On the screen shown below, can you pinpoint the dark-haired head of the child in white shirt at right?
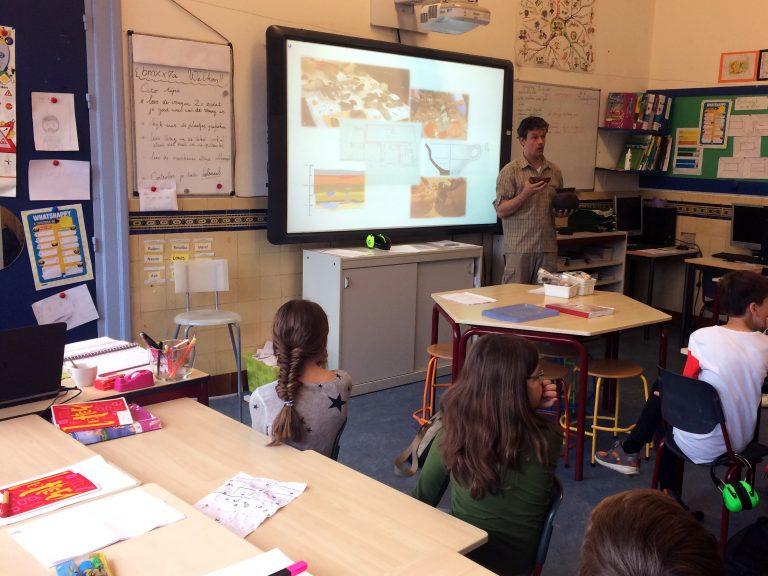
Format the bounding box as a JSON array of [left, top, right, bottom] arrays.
[[717, 271, 768, 330]]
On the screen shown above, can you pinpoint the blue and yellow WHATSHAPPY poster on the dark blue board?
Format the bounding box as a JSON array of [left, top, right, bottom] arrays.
[[21, 204, 93, 290]]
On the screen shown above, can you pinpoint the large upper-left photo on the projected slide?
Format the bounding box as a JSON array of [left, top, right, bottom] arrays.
[[301, 57, 411, 128]]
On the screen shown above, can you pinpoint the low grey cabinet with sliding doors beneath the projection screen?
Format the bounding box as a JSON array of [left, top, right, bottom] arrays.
[[303, 243, 482, 394]]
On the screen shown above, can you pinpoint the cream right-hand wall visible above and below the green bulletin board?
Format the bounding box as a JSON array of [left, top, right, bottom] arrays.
[[638, 0, 768, 311]]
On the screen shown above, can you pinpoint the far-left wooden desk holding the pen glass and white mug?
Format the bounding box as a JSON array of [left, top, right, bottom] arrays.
[[0, 366, 209, 421]]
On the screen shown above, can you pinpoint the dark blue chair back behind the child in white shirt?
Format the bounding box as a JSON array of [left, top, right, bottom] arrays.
[[659, 369, 725, 434]]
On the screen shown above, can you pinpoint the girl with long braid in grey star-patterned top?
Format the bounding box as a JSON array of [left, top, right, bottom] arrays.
[[250, 300, 352, 456]]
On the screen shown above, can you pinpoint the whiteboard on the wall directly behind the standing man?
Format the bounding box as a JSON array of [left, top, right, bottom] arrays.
[[512, 81, 600, 190]]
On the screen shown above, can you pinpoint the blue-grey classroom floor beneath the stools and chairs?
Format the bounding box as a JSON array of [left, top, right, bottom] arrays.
[[211, 330, 768, 576]]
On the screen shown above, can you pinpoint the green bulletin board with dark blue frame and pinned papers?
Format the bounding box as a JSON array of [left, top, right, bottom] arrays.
[[640, 86, 768, 195]]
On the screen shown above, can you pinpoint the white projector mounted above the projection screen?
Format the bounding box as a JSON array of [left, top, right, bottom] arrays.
[[371, 0, 491, 34]]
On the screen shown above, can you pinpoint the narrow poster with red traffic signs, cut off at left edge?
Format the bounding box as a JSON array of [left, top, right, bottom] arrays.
[[0, 25, 16, 196]]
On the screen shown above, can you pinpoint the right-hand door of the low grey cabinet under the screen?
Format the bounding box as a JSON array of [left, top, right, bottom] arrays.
[[414, 258, 475, 370]]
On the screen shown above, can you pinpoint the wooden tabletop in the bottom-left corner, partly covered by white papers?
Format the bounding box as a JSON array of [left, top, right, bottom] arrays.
[[0, 484, 260, 576]]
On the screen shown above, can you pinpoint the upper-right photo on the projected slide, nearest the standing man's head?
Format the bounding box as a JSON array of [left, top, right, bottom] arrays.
[[411, 89, 469, 140]]
